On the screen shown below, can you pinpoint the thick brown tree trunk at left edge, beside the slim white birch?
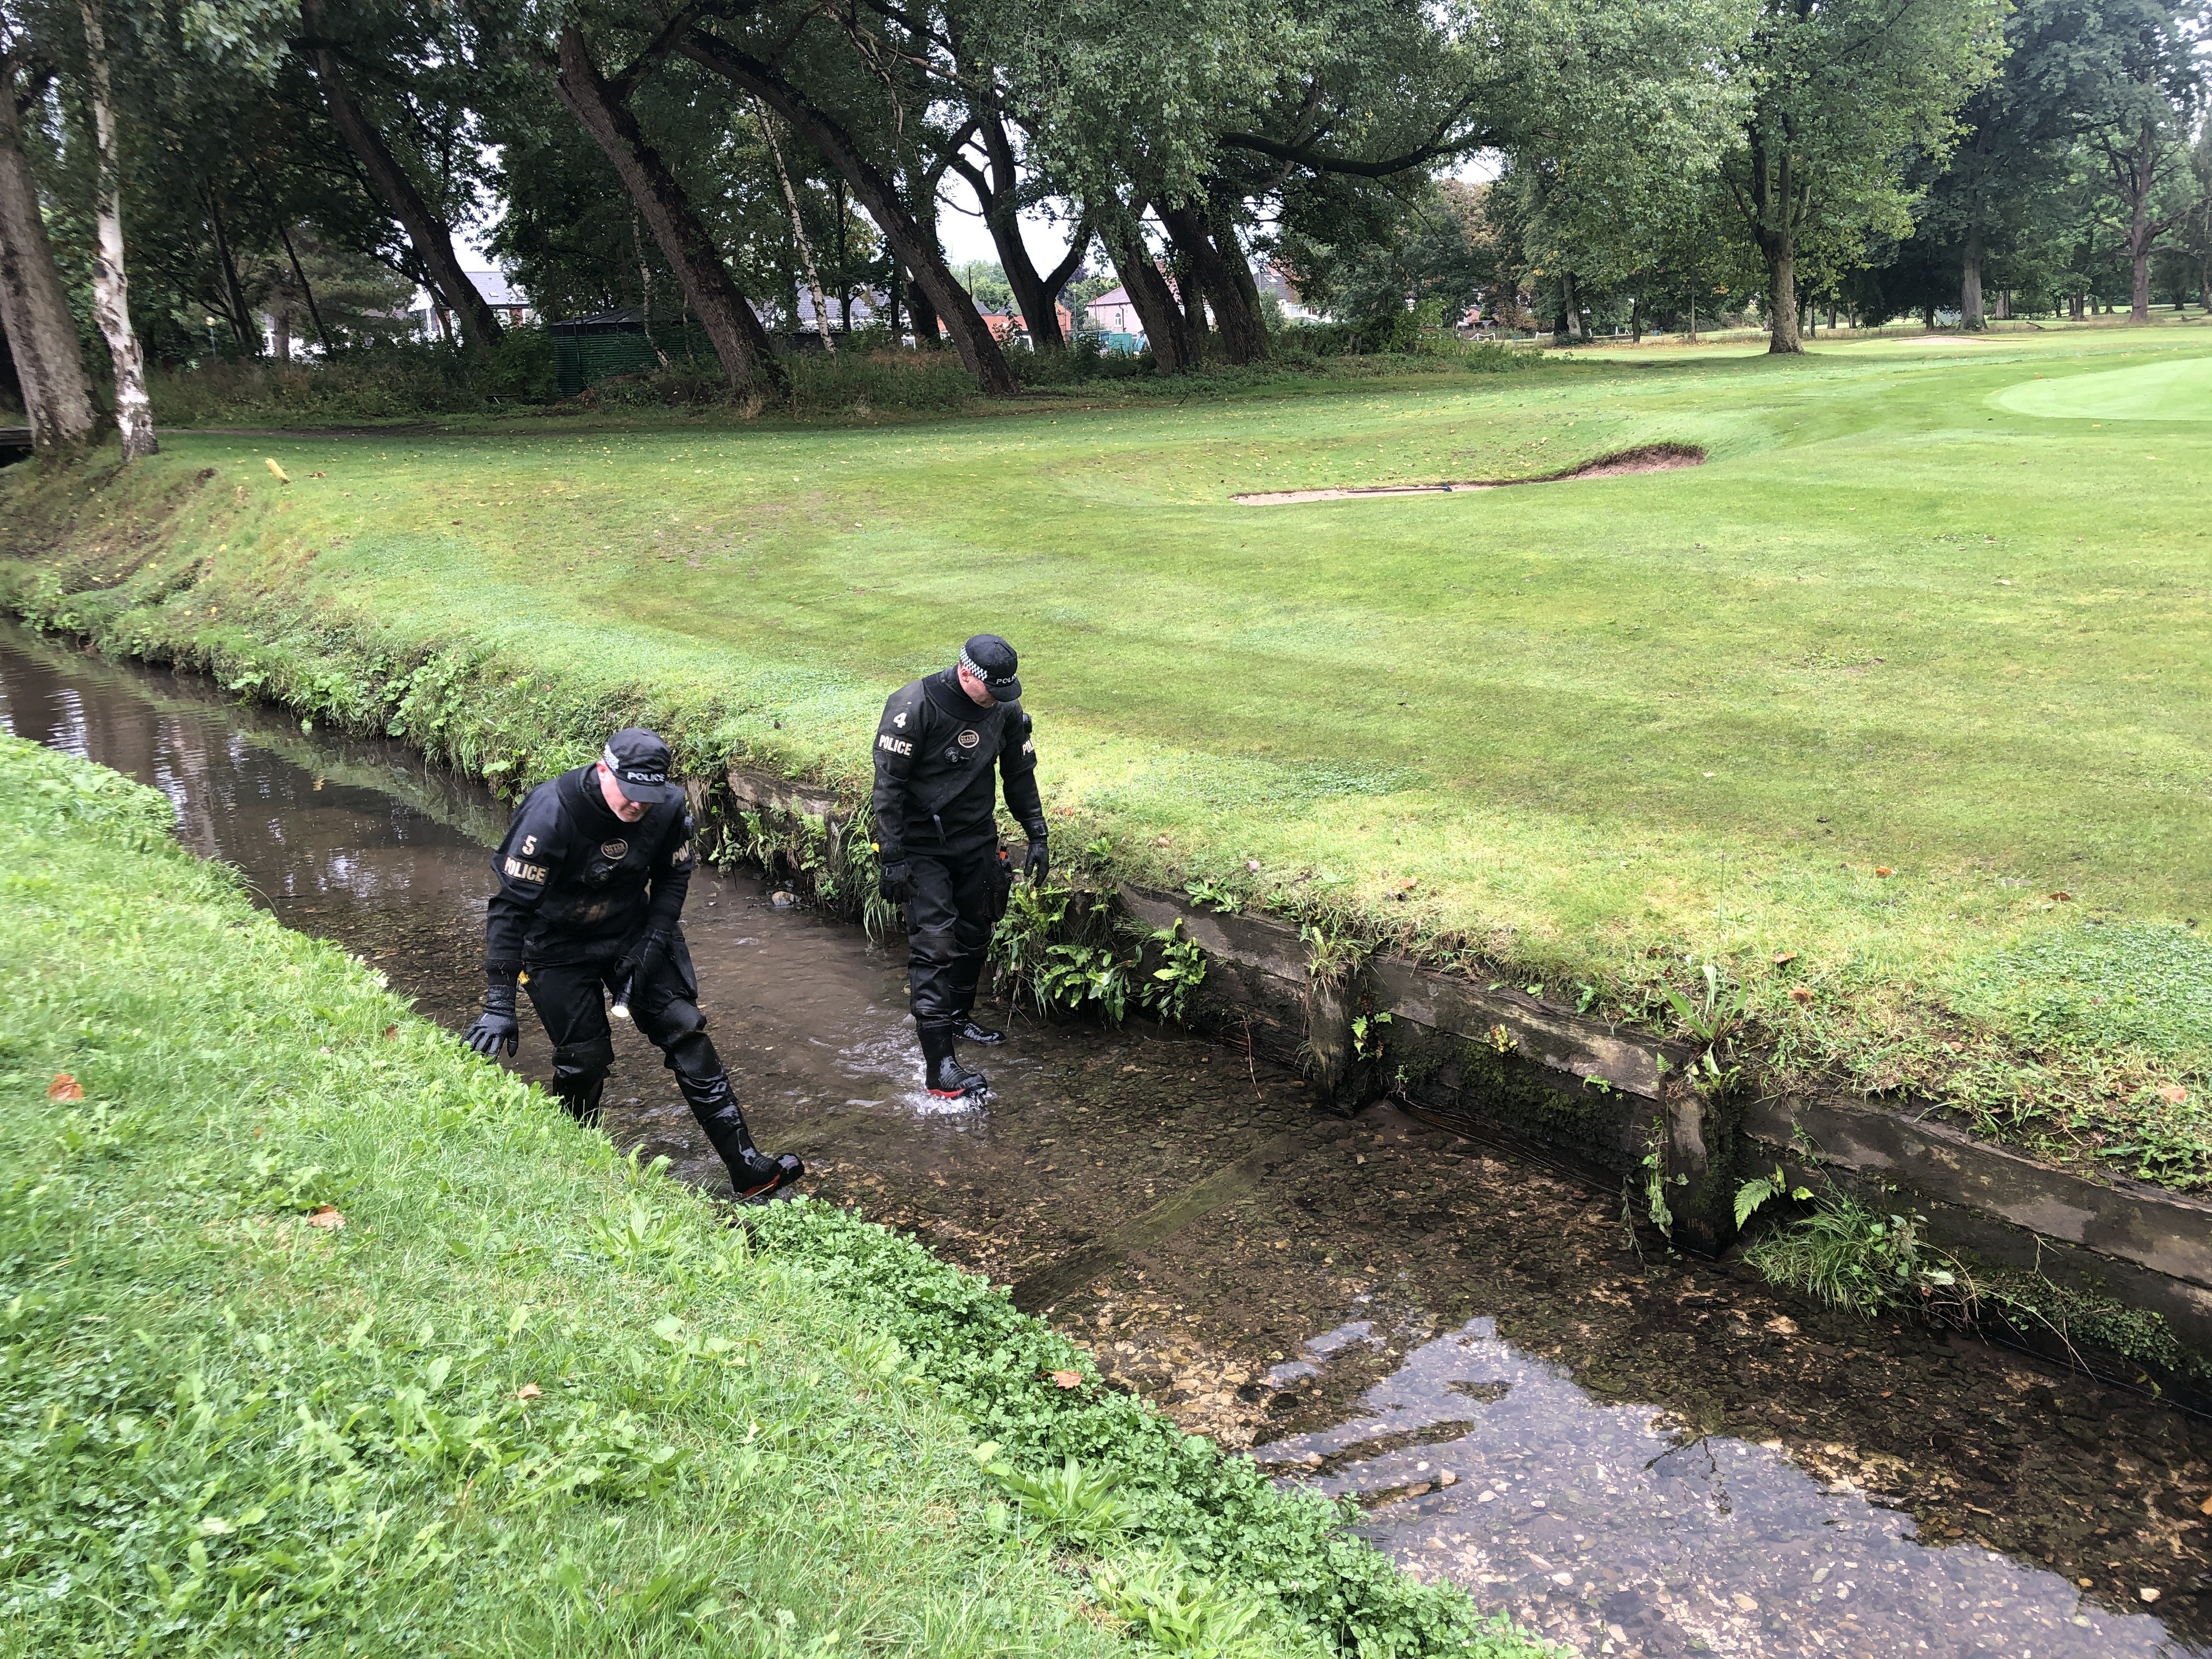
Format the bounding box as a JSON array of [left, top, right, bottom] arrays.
[[0, 55, 95, 456]]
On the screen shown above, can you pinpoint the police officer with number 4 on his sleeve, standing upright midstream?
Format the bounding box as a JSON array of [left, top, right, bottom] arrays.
[[876, 633, 1051, 1099]]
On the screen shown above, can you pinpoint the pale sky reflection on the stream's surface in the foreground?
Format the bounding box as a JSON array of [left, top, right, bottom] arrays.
[[1252, 1318, 2199, 1659]]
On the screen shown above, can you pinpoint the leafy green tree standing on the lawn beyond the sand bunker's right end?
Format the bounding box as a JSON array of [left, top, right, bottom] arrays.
[[1721, 0, 2004, 352]]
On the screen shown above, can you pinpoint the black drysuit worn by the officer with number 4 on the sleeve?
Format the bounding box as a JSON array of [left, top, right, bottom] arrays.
[[876, 668, 1044, 1031]]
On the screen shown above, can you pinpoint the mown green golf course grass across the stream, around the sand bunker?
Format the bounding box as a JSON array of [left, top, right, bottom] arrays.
[[0, 325, 2212, 1190]]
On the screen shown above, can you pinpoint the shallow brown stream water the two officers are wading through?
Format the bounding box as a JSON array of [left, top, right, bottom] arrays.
[[13, 630, 2212, 1659]]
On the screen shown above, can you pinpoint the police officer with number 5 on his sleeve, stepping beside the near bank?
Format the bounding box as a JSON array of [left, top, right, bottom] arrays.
[[469, 725, 805, 1199]]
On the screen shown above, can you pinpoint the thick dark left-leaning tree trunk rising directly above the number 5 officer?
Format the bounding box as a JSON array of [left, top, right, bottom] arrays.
[[553, 24, 785, 400]]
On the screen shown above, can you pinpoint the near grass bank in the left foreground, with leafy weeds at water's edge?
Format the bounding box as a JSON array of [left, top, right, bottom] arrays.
[[0, 739, 1535, 1659]]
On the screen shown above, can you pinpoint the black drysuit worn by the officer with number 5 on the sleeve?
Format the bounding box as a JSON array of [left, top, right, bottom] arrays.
[[484, 765, 735, 1124]]
